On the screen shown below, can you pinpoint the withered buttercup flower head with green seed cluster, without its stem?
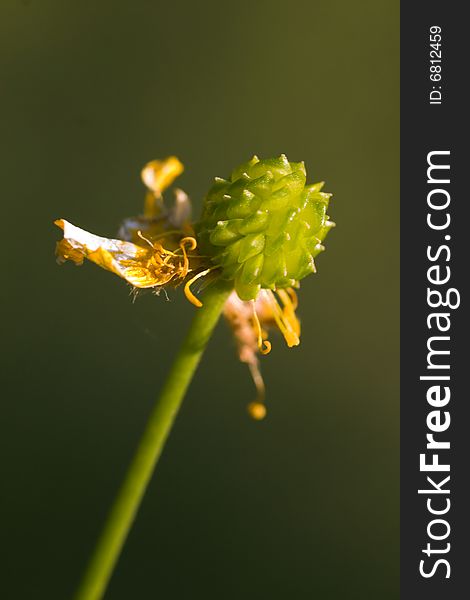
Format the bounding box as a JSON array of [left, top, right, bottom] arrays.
[[55, 155, 334, 419]]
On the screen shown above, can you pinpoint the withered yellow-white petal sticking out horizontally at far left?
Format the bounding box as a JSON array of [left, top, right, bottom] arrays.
[[55, 219, 193, 288]]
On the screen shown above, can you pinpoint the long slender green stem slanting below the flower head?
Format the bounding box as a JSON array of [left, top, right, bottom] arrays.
[[75, 283, 230, 600]]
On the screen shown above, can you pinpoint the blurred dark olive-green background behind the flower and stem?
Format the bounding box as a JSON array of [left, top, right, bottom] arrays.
[[0, 0, 399, 600]]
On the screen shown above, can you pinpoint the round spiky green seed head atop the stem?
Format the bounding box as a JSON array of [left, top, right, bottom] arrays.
[[198, 154, 333, 300]]
